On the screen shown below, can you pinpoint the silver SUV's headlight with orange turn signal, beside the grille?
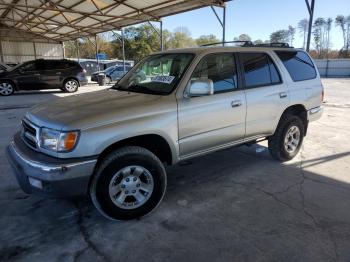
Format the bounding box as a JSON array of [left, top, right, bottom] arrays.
[[40, 128, 79, 152]]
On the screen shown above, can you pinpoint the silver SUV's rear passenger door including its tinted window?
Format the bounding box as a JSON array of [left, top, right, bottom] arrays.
[[239, 52, 289, 138]]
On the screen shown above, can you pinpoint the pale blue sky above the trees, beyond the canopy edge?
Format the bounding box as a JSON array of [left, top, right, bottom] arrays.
[[163, 0, 350, 49]]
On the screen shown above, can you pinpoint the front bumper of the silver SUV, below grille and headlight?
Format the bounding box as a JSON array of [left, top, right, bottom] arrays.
[[6, 137, 97, 197]]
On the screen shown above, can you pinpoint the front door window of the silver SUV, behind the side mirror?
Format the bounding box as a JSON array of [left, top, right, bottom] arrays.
[[191, 53, 238, 94]]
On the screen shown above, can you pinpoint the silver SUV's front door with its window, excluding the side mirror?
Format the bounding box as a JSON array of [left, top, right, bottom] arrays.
[[178, 53, 246, 158]]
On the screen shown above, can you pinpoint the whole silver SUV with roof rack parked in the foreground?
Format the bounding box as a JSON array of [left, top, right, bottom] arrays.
[[7, 46, 323, 220]]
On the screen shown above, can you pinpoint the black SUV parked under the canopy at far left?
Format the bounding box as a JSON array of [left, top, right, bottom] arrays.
[[0, 59, 88, 96]]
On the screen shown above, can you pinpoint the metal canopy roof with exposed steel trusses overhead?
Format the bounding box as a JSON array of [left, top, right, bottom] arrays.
[[0, 0, 227, 41]]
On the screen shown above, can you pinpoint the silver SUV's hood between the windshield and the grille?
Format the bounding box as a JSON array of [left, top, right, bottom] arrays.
[[26, 89, 164, 130]]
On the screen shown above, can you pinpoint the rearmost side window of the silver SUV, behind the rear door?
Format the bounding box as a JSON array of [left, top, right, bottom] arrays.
[[275, 51, 317, 82]]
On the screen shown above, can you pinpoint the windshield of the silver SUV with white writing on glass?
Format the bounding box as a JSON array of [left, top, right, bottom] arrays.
[[113, 53, 194, 95]]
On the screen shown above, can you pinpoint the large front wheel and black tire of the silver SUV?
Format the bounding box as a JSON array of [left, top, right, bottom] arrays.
[[90, 146, 167, 220]]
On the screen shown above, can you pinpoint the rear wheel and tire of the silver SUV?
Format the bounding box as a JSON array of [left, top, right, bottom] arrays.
[[268, 114, 305, 162]]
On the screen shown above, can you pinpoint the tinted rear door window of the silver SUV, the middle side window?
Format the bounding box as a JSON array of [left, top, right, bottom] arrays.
[[239, 53, 281, 87]]
